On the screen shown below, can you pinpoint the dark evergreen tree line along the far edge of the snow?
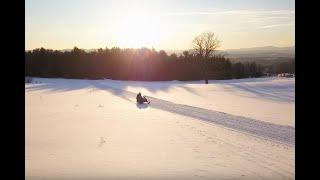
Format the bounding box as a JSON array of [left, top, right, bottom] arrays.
[[25, 47, 262, 81]]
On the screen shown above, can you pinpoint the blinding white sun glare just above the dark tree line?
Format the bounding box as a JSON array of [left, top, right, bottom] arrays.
[[116, 12, 160, 48]]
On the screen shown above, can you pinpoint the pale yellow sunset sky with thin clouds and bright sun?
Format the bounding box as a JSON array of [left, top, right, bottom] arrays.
[[25, 0, 295, 50]]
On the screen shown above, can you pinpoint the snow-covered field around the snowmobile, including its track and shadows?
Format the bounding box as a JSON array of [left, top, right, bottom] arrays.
[[25, 78, 295, 179]]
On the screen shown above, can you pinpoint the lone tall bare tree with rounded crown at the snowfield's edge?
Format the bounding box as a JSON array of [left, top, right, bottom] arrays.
[[193, 32, 220, 84]]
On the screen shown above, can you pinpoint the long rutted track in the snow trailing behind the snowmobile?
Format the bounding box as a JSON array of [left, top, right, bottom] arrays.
[[147, 96, 295, 145]]
